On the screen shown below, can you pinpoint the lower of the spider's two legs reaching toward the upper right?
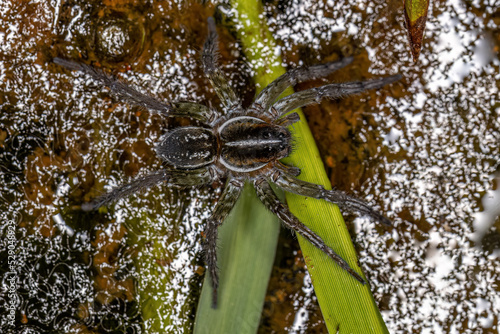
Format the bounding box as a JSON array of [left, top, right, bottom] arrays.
[[273, 74, 401, 117]]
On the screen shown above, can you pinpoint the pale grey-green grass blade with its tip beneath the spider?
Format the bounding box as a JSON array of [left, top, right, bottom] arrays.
[[194, 184, 279, 334]]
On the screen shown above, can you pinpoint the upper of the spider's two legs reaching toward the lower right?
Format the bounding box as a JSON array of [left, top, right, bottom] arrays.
[[273, 172, 391, 226]]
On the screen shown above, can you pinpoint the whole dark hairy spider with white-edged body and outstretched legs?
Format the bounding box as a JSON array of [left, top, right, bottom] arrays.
[[54, 19, 400, 307]]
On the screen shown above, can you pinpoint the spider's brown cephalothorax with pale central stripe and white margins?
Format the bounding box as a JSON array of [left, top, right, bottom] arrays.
[[219, 116, 291, 172]]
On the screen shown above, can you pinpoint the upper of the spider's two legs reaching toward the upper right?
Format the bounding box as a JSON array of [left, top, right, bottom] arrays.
[[250, 57, 353, 116]]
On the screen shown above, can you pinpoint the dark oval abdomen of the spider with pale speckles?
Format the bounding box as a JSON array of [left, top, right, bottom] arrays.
[[156, 126, 217, 169]]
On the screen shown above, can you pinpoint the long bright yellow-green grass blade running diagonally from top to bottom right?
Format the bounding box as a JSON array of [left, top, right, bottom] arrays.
[[229, 1, 387, 333]]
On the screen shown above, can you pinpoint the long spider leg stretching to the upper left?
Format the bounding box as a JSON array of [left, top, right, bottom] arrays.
[[54, 58, 215, 123]]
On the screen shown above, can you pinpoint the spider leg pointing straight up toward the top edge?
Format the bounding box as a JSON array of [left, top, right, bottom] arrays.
[[201, 17, 240, 109]]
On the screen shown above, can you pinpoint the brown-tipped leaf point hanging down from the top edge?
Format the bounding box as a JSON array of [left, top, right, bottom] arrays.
[[404, 0, 430, 62]]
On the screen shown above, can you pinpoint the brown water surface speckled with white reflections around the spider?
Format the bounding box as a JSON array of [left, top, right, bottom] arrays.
[[0, 0, 500, 333]]
